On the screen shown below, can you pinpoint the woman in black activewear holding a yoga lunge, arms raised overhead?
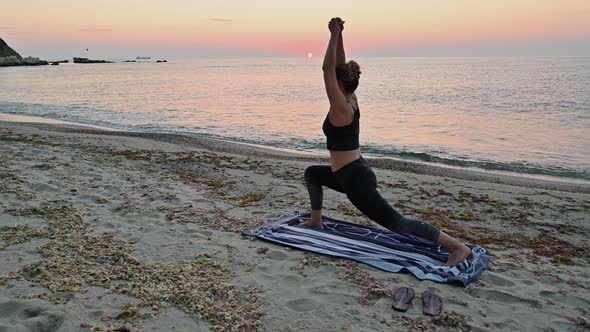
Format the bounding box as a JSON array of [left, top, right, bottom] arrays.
[[303, 18, 471, 265]]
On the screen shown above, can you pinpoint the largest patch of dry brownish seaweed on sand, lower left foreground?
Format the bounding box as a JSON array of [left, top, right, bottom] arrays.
[[0, 206, 263, 331]]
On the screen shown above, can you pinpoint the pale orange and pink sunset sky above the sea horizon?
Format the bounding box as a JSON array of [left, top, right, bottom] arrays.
[[0, 0, 590, 58]]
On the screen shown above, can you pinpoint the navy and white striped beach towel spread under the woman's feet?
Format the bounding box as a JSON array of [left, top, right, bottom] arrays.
[[243, 212, 490, 286]]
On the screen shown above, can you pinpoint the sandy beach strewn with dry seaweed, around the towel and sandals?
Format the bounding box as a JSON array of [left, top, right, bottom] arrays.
[[0, 121, 590, 331]]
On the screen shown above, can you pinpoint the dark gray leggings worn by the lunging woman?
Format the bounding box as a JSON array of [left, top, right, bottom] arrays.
[[305, 158, 440, 242]]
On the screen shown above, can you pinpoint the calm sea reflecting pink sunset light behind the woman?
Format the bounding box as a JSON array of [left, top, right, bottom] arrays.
[[0, 57, 590, 180]]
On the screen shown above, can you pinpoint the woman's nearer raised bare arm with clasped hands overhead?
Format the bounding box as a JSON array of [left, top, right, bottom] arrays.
[[322, 18, 346, 109]]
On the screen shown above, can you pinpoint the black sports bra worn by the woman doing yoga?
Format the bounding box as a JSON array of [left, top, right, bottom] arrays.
[[322, 106, 361, 151]]
